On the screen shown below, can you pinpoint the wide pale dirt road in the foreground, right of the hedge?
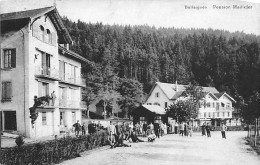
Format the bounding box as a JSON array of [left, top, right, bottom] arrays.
[[59, 132, 260, 165]]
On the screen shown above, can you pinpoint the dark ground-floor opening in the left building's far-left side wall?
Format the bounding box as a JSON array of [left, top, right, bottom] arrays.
[[4, 111, 17, 130]]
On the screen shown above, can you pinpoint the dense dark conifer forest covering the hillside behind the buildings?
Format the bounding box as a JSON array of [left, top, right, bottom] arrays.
[[63, 17, 260, 107]]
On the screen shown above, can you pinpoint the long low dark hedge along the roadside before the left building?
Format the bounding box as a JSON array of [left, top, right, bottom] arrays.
[[1, 131, 108, 165]]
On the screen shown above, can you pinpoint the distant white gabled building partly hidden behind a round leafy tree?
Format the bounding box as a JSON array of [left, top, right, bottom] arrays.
[[145, 82, 236, 126]]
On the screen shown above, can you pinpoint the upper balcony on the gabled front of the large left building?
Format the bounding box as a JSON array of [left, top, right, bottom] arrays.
[[34, 66, 59, 80]]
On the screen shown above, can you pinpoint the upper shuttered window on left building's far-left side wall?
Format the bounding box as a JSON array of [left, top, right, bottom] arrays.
[[3, 49, 16, 68]]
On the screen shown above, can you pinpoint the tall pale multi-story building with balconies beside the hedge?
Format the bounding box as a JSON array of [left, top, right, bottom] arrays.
[[0, 7, 88, 137]]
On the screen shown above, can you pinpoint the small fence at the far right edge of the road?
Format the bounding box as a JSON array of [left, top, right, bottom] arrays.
[[247, 122, 260, 146]]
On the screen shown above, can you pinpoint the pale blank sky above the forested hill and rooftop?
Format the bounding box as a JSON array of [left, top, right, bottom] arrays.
[[0, 0, 260, 35]]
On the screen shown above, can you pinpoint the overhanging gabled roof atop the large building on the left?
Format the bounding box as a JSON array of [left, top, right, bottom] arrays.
[[0, 6, 72, 44]]
